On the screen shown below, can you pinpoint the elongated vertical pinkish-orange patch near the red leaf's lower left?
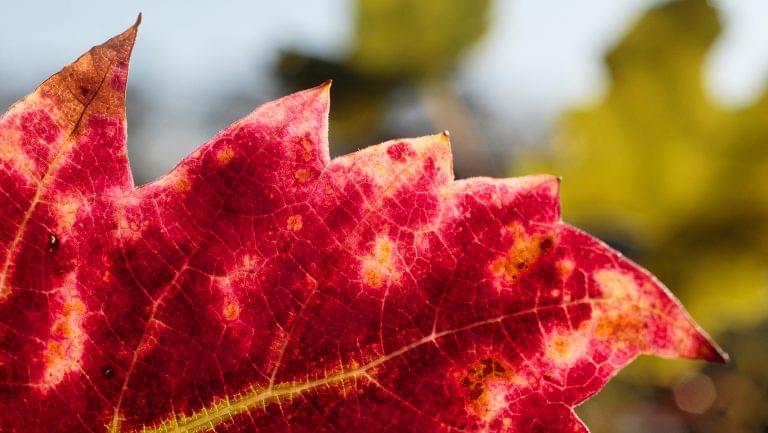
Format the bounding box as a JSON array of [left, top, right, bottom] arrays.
[[40, 272, 85, 392]]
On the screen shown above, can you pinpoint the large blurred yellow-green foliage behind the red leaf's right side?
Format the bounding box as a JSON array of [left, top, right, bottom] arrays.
[[516, 0, 768, 340]]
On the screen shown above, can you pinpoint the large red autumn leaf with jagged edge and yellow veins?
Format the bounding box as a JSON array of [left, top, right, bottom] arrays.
[[0, 17, 725, 433]]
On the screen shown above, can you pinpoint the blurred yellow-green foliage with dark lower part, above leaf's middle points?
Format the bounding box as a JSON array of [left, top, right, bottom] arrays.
[[277, 0, 490, 157]]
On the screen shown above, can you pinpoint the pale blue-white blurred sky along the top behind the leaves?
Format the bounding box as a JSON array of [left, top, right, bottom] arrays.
[[0, 0, 768, 177]]
